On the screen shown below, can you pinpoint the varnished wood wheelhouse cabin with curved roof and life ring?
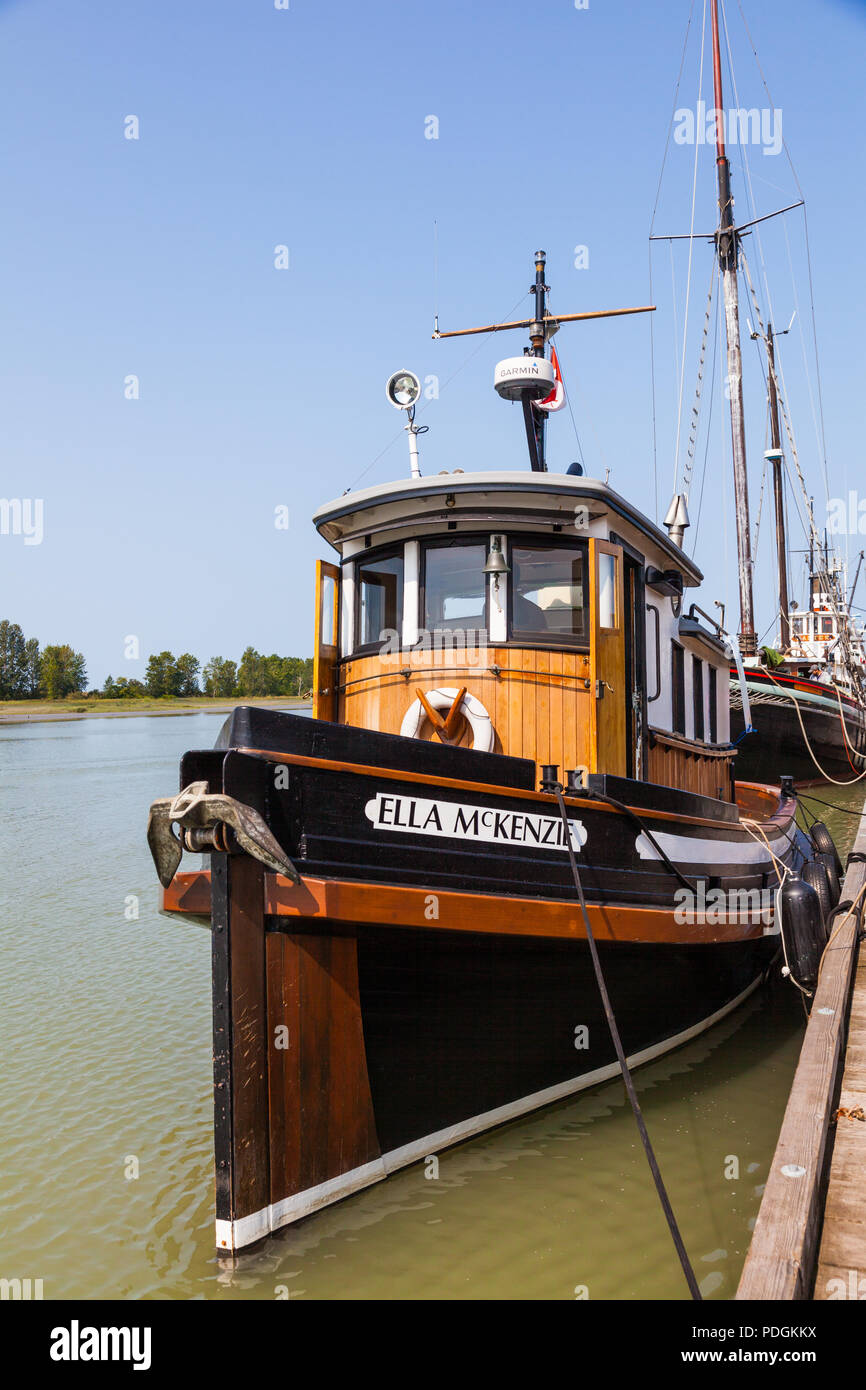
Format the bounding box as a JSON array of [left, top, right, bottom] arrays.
[[313, 470, 734, 799]]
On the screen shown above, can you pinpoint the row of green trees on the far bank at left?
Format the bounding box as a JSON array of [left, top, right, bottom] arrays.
[[0, 619, 313, 699]]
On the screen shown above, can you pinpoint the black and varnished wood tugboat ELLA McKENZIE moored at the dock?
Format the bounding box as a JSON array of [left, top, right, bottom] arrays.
[[149, 252, 815, 1255]]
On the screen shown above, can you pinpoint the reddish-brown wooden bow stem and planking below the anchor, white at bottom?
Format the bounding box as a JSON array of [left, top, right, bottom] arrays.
[[211, 853, 385, 1255]]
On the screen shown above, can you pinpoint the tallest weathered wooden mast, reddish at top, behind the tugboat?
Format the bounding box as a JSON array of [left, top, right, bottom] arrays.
[[712, 0, 756, 656]]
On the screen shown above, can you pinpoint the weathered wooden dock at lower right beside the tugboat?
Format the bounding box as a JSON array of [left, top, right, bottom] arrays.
[[737, 806, 866, 1300]]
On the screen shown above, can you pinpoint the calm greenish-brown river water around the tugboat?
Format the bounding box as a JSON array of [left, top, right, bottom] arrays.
[[0, 714, 862, 1298]]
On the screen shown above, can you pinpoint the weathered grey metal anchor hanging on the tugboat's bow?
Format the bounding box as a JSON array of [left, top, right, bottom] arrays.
[[147, 781, 300, 888]]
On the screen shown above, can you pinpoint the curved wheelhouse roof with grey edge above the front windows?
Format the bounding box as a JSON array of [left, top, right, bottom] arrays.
[[313, 471, 703, 587]]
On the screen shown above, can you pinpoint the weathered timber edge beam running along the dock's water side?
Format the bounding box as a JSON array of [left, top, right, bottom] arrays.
[[737, 806, 866, 1300]]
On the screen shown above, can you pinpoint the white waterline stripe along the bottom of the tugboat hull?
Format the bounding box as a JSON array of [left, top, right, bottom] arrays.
[[215, 974, 762, 1254]]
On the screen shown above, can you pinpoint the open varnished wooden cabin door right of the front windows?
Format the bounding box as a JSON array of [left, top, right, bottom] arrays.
[[589, 538, 622, 777]]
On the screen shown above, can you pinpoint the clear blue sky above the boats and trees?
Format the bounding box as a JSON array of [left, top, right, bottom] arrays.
[[0, 0, 866, 684]]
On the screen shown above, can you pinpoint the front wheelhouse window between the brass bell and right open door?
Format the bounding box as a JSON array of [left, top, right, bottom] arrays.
[[509, 541, 587, 642]]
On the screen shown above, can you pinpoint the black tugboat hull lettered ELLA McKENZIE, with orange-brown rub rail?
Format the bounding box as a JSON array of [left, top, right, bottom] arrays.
[[150, 710, 813, 1252]]
